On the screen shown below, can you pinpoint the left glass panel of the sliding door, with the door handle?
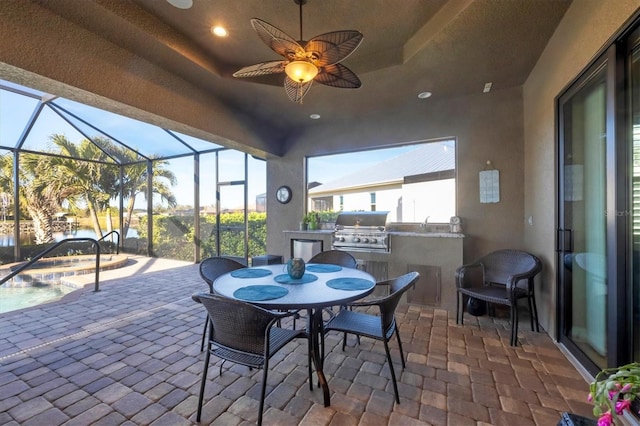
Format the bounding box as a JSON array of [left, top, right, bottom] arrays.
[[558, 62, 607, 367]]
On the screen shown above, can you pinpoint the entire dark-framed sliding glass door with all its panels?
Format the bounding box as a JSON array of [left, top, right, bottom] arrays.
[[556, 22, 640, 373]]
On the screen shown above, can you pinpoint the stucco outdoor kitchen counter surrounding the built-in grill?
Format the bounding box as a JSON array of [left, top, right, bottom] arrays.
[[282, 230, 464, 310]]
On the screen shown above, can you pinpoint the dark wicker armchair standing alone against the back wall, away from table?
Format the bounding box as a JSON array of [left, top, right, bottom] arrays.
[[456, 249, 542, 346]]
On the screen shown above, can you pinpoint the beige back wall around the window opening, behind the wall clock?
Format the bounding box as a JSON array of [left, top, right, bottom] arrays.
[[267, 88, 524, 261]]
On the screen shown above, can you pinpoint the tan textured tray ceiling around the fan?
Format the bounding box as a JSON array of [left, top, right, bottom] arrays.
[[41, 0, 571, 142]]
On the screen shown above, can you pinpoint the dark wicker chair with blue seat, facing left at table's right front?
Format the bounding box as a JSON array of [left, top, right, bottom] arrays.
[[322, 272, 420, 404]]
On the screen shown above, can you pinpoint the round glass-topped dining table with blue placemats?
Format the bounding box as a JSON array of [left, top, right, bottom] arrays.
[[213, 263, 376, 407]]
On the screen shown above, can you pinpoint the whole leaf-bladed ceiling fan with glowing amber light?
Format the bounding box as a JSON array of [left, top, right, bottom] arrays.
[[233, 0, 363, 103]]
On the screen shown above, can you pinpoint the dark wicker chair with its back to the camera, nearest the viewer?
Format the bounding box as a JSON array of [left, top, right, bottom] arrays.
[[192, 293, 313, 425]]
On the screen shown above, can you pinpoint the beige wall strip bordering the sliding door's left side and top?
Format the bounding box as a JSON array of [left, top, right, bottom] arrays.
[[523, 0, 640, 336]]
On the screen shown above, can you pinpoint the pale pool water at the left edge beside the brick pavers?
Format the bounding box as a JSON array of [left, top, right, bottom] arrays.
[[0, 285, 76, 313]]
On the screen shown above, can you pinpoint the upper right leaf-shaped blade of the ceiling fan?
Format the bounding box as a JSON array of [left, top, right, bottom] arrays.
[[304, 30, 364, 67]]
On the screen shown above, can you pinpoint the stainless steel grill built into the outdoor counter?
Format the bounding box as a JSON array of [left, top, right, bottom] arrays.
[[333, 212, 391, 253]]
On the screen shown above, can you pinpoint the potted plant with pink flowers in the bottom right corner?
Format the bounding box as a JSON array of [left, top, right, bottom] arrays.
[[588, 362, 640, 426]]
